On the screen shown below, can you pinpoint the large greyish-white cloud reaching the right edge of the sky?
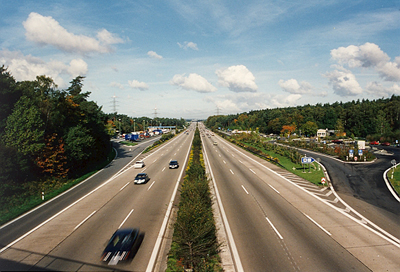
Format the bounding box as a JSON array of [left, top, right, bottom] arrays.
[[331, 43, 400, 81]]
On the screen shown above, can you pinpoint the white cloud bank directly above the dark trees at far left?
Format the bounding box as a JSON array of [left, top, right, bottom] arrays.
[[0, 50, 88, 87]]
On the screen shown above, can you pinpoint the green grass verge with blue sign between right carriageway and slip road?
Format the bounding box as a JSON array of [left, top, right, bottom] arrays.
[[242, 142, 328, 186]]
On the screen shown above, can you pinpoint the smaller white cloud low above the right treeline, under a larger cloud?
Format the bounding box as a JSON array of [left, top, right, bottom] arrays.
[[323, 65, 362, 96]]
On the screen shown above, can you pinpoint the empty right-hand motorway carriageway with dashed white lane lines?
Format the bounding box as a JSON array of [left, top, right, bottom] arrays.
[[202, 124, 400, 271]]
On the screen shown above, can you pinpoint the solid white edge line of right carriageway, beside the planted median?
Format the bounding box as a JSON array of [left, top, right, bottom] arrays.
[[202, 138, 244, 272]]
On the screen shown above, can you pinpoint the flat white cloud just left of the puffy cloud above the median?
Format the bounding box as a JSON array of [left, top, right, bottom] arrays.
[[170, 74, 217, 93]]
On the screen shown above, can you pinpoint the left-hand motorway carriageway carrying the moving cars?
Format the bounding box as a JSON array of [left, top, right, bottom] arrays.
[[0, 126, 193, 271]]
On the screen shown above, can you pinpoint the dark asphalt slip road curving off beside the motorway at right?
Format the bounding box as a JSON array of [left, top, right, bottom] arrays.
[[300, 147, 400, 239]]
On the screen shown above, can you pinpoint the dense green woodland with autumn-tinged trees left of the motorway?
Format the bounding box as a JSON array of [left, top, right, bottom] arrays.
[[0, 66, 186, 198]]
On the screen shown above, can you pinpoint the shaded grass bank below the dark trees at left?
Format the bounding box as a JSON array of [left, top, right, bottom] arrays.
[[0, 149, 116, 226]]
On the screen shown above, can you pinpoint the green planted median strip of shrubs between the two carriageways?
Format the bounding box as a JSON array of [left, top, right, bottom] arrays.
[[166, 126, 222, 271]]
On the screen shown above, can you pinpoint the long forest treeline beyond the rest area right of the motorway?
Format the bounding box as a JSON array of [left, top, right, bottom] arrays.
[[206, 95, 400, 141]]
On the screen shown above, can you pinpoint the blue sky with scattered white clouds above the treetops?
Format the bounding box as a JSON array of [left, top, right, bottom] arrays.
[[0, 0, 400, 119]]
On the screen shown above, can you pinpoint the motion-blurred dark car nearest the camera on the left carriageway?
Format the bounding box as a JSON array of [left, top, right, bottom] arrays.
[[101, 228, 139, 265]]
